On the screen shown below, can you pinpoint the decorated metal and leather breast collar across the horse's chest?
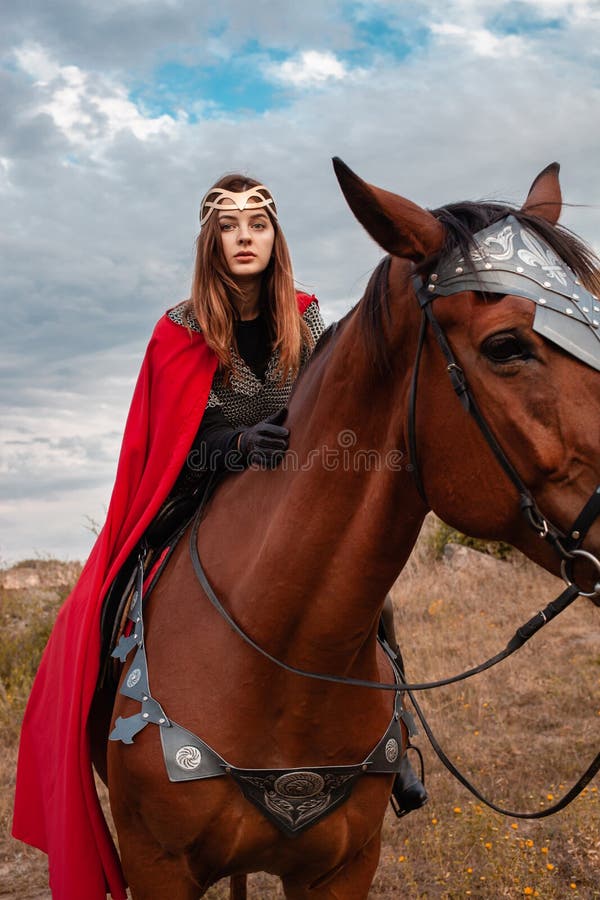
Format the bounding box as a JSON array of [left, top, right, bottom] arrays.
[[109, 531, 416, 837]]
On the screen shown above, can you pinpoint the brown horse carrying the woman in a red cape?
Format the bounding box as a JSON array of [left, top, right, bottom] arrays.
[[108, 164, 600, 900]]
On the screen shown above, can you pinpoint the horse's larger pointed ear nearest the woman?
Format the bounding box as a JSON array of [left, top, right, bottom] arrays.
[[333, 156, 445, 262]]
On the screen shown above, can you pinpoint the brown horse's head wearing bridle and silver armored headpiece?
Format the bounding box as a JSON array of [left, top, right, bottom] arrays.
[[334, 160, 600, 600]]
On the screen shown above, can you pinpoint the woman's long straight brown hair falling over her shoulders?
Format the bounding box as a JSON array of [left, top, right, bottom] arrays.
[[189, 174, 312, 381]]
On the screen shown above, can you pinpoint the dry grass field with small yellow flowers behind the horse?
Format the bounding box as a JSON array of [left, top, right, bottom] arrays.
[[0, 522, 600, 900]]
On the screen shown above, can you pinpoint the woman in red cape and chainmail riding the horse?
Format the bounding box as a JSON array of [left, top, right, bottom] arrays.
[[9, 175, 426, 900]]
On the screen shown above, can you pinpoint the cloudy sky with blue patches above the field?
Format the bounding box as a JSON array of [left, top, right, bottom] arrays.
[[0, 0, 600, 564]]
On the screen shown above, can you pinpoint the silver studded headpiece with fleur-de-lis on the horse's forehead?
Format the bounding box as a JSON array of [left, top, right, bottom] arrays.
[[426, 216, 600, 371]]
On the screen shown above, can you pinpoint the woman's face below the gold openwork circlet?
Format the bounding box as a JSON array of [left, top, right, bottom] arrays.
[[219, 207, 275, 282]]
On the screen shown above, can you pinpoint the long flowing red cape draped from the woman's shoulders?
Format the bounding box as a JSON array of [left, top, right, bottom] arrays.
[[13, 294, 314, 900]]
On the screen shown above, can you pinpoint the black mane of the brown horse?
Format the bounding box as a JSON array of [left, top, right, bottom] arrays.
[[356, 200, 600, 374]]
